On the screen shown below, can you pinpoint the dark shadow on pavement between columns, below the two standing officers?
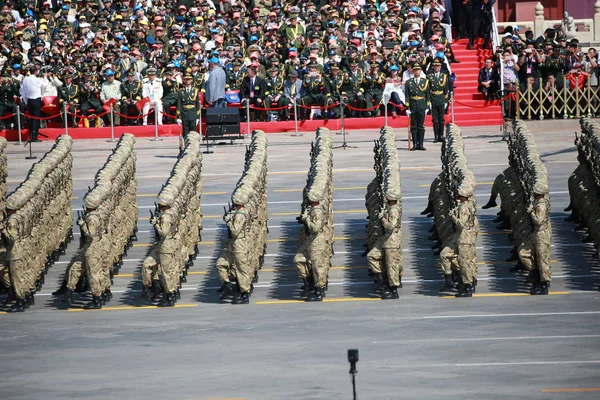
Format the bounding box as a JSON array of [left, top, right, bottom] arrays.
[[402, 216, 443, 297]]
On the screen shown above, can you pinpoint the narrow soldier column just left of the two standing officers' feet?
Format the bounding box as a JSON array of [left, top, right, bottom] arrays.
[[365, 127, 403, 299]]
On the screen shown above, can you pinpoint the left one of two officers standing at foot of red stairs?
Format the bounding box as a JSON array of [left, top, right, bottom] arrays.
[[404, 63, 431, 151]]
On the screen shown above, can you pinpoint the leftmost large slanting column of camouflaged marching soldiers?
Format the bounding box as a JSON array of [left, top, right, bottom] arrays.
[[2, 135, 73, 312]]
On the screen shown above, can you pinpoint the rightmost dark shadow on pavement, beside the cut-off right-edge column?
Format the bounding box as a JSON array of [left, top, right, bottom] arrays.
[[550, 210, 600, 291]]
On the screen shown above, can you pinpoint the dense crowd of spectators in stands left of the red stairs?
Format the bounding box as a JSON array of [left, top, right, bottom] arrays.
[[0, 0, 493, 139]]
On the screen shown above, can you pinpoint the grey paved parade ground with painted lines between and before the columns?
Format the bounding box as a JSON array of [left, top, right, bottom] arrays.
[[0, 121, 600, 400]]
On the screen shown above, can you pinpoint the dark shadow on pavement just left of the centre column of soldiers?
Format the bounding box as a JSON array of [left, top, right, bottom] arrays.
[[268, 221, 302, 300]]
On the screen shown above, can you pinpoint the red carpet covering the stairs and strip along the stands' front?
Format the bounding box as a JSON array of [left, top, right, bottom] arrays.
[[0, 40, 502, 141]]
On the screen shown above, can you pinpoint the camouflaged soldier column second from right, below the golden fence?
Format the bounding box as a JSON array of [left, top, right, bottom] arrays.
[[482, 121, 552, 294]]
